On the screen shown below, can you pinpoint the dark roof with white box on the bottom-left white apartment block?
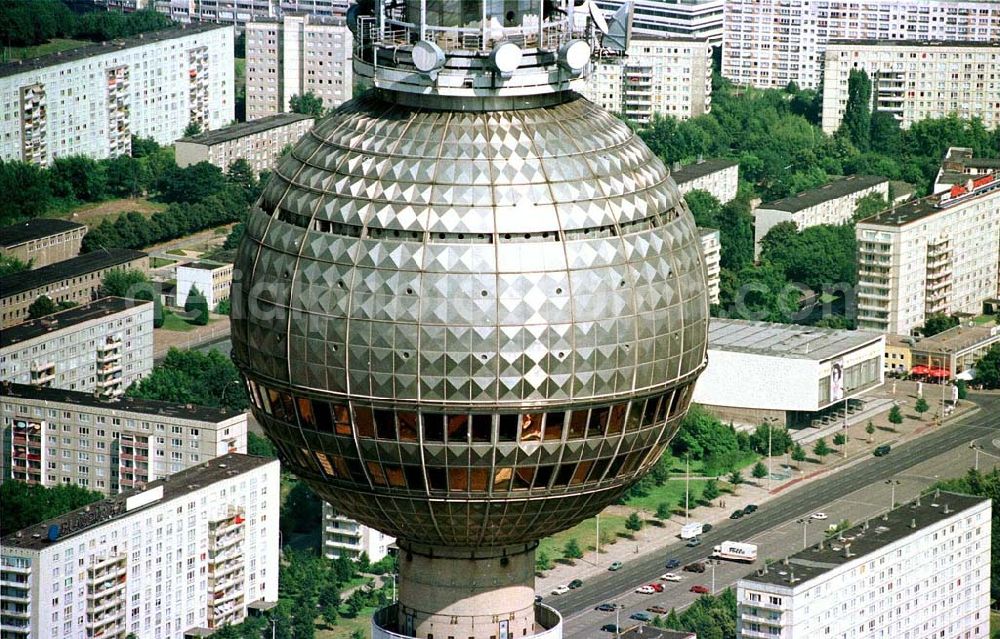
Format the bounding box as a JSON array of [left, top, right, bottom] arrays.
[[0, 453, 278, 551]]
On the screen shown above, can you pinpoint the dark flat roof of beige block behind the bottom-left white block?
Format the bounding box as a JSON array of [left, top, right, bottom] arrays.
[[0, 382, 243, 424]]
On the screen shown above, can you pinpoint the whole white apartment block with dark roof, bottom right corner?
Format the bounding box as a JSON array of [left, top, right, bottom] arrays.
[[736, 492, 992, 639]]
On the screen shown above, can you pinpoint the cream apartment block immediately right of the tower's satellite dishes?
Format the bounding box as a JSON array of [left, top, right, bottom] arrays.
[[583, 36, 712, 125]]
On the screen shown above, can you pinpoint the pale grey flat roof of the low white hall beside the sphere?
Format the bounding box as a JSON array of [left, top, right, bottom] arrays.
[[708, 318, 882, 361]]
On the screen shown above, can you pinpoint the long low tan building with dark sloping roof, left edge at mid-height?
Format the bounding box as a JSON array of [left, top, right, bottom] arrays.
[[0, 249, 149, 328]]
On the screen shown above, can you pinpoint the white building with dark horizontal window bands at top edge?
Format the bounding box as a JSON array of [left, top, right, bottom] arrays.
[[597, 0, 724, 46]]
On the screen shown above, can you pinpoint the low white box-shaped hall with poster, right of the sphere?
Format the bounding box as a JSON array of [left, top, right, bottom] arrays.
[[693, 318, 885, 426]]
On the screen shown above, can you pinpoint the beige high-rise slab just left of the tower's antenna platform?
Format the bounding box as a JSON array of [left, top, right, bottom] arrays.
[[246, 15, 354, 120]]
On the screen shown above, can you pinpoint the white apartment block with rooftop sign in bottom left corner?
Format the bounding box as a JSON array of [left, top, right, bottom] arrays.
[[0, 454, 280, 639]]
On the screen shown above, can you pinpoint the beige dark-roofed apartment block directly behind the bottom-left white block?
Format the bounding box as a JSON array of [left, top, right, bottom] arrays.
[[0, 382, 247, 495]]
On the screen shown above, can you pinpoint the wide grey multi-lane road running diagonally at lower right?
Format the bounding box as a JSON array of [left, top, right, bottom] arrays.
[[542, 395, 1000, 637]]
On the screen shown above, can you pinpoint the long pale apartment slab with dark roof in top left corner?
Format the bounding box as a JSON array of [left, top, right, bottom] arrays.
[[0, 24, 235, 165]]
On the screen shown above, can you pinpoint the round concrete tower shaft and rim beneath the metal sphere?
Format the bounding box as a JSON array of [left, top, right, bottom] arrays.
[[372, 542, 562, 639]]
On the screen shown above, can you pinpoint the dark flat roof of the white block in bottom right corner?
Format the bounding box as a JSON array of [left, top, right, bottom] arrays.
[[743, 492, 990, 588]]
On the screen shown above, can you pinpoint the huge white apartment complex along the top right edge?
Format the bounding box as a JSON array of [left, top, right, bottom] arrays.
[[722, 0, 1000, 89]]
